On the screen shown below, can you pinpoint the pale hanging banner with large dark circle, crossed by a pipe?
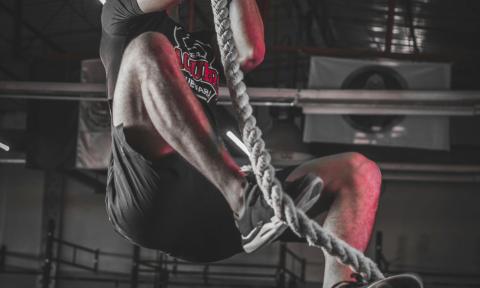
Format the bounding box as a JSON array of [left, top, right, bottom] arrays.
[[303, 57, 451, 150]]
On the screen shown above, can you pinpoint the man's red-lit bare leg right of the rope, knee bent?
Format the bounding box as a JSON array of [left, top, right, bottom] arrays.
[[287, 153, 381, 288]]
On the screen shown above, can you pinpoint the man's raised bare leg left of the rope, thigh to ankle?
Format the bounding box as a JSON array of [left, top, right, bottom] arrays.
[[113, 32, 245, 213]]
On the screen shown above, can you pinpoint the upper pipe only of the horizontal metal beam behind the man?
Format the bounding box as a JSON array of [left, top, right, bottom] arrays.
[[0, 81, 480, 104]]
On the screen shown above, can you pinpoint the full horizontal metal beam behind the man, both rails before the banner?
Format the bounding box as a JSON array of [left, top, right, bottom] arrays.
[[0, 82, 480, 116]]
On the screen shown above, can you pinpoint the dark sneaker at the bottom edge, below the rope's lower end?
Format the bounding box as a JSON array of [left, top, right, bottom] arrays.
[[332, 274, 423, 288]]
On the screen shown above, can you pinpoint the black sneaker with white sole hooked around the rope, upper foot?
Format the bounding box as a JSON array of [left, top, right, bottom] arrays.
[[236, 174, 323, 253]]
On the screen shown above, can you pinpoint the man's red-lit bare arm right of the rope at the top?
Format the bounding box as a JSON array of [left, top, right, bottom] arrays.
[[230, 0, 265, 72]]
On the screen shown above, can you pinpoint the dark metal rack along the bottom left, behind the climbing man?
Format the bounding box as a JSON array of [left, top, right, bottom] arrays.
[[0, 221, 306, 288]]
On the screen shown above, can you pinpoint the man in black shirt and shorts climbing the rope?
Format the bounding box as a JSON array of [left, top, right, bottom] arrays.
[[100, 0, 381, 287]]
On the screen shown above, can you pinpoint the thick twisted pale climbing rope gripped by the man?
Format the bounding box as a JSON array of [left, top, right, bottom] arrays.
[[212, 0, 384, 281]]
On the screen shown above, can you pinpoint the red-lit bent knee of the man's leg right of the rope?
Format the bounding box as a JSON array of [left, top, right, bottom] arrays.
[[344, 152, 382, 198]]
